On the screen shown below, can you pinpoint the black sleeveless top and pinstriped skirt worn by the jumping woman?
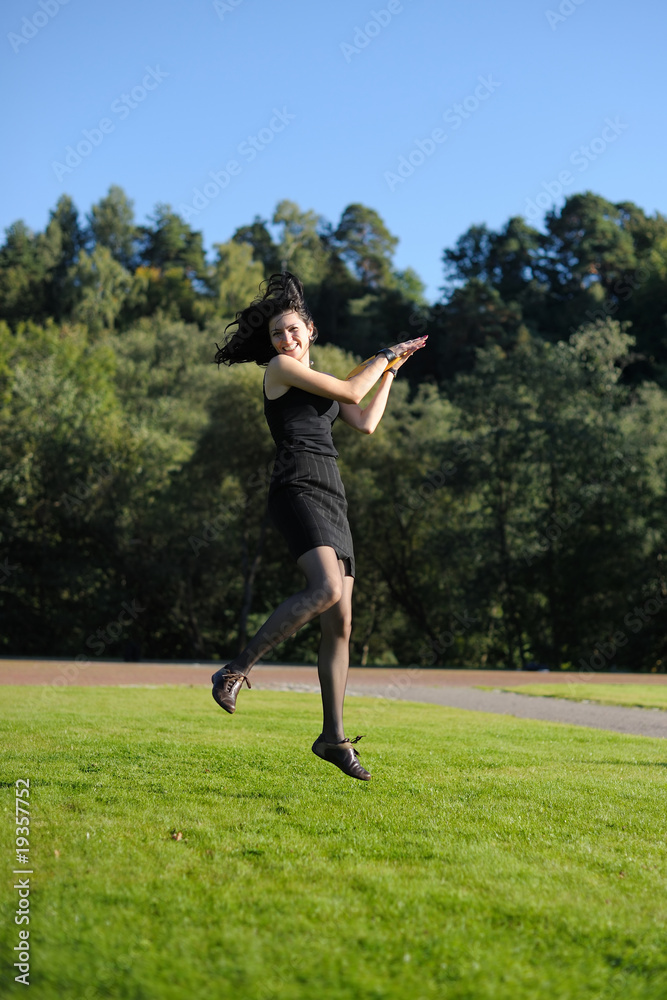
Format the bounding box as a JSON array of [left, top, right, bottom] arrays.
[[264, 376, 355, 576]]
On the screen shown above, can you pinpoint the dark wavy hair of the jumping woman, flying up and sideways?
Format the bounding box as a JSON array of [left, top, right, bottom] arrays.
[[214, 271, 317, 365]]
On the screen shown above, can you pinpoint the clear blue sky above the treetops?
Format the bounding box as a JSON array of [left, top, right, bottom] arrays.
[[0, 0, 667, 300]]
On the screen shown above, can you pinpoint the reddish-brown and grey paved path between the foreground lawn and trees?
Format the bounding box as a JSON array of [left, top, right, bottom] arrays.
[[0, 659, 667, 738]]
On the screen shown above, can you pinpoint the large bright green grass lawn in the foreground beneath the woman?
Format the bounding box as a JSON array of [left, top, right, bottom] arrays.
[[0, 687, 667, 1000]]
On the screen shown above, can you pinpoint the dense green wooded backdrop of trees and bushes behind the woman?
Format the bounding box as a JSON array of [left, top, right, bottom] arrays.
[[0, 188, 667, 671]]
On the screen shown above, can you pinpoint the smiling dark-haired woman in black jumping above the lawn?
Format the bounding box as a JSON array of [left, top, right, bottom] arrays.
[[211, 271, 426, 781]]
